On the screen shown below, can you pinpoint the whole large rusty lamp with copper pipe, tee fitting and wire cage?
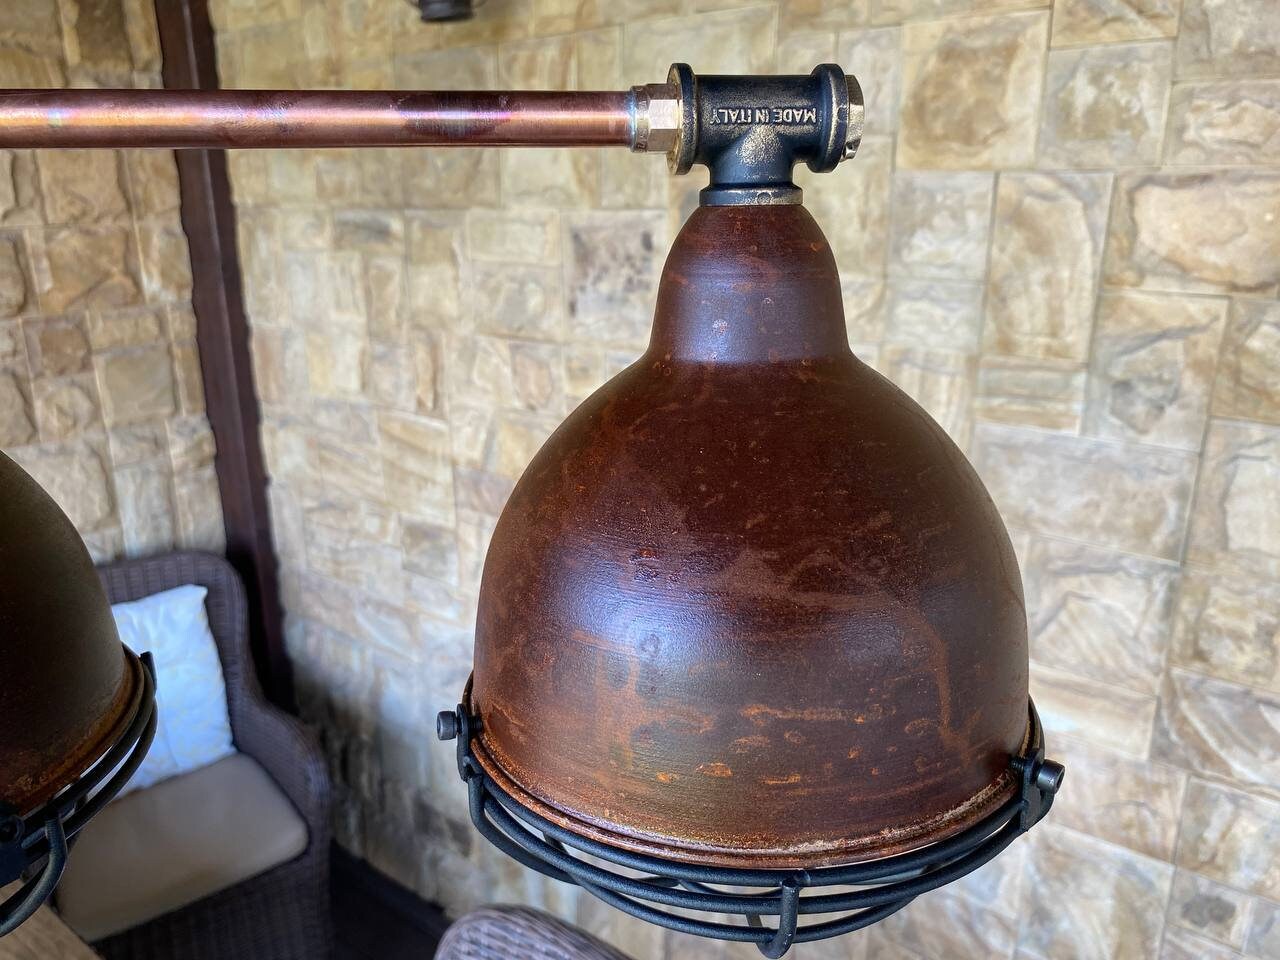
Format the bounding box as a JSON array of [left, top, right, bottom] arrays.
[[0, 64, 1062, 957]]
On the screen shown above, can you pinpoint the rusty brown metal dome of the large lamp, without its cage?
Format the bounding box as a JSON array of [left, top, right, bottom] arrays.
[[468, 205, 1028, 868]]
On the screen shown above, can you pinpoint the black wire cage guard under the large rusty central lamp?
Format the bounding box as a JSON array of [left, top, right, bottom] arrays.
[[436, 703, 1065, 959]]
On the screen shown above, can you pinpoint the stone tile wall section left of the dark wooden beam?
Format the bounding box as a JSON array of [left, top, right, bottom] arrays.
[[0, 0, 223, 561]]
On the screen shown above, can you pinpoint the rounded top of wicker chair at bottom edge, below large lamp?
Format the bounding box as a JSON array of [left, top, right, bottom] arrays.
[[435, 906, 631, 960]]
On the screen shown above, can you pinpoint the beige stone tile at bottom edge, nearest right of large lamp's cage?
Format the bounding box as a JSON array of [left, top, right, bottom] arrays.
[[1020, 824, 1172, 960]]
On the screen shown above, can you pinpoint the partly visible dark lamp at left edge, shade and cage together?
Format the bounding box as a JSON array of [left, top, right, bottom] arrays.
[[0, 453, 155, 936]]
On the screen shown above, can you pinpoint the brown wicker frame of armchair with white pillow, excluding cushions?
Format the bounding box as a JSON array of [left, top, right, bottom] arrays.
[[73, 553, 333, 960]]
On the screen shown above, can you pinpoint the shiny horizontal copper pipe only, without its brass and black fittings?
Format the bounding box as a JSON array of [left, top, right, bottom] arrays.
[[0, 90, 635, 148]]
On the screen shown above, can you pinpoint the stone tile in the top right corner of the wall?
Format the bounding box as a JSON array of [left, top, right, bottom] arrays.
[[1178, 0, 1280, 78]]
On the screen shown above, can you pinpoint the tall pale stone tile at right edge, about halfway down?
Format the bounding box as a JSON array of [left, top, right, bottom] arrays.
[[1187, 420, 1280, 577]]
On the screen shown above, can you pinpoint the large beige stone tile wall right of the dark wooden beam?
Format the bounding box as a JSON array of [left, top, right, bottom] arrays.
[[209, 0, 1280, 960]]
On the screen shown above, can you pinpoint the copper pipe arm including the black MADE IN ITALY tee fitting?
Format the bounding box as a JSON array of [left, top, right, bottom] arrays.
[[0, 64, 863, 205]]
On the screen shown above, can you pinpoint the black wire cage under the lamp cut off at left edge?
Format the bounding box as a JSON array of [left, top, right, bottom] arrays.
[[0, 653, 156, 937]]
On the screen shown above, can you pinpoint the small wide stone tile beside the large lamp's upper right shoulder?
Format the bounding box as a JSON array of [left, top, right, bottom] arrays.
[[974, 357, 1085, 434]]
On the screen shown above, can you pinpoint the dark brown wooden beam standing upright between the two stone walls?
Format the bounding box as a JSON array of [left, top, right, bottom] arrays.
[[155, 0, 293, 707]]
